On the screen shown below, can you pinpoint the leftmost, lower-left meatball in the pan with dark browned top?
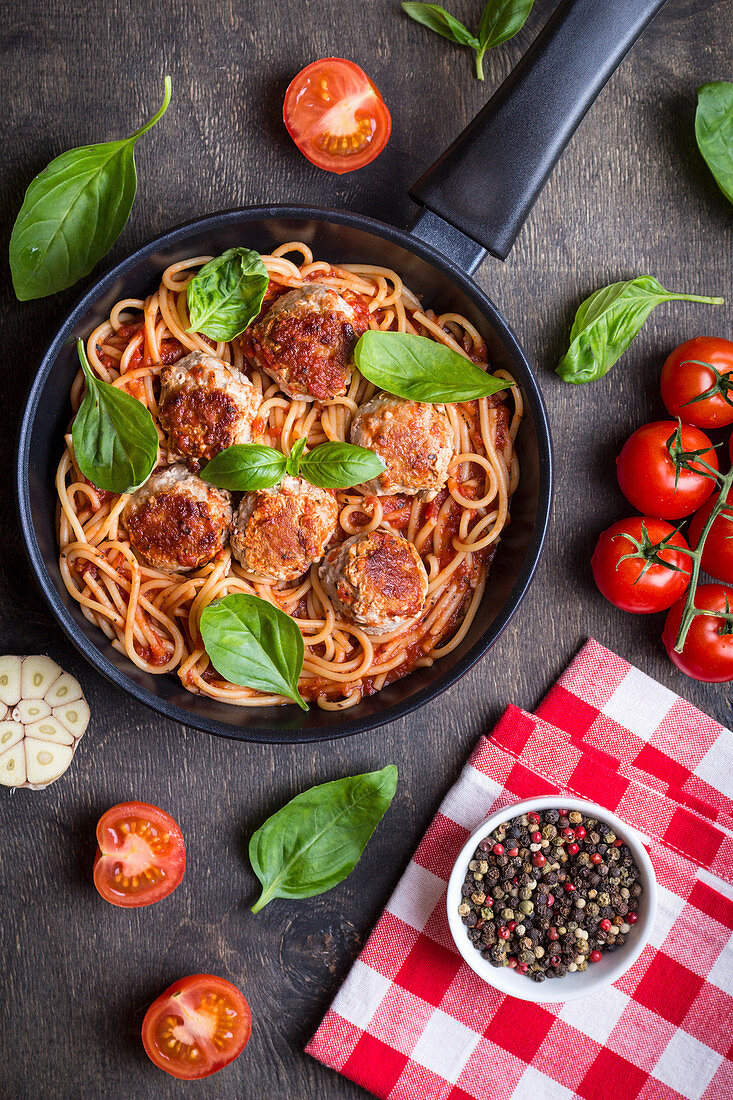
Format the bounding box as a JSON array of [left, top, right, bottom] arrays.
[[122, 464, 232, 573]]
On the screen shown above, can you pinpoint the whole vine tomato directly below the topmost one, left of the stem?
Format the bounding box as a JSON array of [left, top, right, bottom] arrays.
[[616, 420, 718, 519]]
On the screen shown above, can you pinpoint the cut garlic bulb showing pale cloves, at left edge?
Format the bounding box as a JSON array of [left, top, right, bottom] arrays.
[[0, 656, 89, 790]]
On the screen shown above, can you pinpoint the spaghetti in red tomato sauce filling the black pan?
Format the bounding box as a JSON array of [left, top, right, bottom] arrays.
[[56, 242, 522, 710]]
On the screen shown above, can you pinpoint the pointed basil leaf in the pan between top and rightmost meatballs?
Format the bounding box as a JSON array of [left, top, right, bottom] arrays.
[[353, 329, 511, 405]]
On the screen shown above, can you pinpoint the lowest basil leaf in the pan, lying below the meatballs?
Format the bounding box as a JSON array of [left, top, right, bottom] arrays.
[[200, 593, 308, 711]]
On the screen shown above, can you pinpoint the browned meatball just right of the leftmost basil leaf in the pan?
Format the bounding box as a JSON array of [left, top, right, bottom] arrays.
[[158, 351, 262, 472]]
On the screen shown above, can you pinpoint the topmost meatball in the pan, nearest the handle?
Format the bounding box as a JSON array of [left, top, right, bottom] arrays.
[[247, 283, 369, 402]]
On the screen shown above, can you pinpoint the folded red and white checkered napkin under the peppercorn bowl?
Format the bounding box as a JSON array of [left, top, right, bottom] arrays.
[[307, 641, 733, 1100]]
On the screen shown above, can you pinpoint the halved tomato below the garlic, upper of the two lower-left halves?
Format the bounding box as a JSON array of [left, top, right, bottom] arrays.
[[95, 802, 186, 909]]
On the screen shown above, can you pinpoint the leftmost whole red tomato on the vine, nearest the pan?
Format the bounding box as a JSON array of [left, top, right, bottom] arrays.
[[591, 516, 691, 615]]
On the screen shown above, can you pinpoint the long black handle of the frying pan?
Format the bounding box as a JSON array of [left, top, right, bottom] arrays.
[[409, 0, 665, 260]]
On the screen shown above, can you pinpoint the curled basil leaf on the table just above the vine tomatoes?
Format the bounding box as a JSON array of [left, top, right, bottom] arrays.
[[557, 275, 723, 384]]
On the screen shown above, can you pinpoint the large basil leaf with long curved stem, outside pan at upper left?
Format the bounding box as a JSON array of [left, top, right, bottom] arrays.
[[10, 76, 171, 301]]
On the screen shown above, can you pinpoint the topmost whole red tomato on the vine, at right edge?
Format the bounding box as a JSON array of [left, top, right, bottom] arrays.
[[660, 337, 733, 428]]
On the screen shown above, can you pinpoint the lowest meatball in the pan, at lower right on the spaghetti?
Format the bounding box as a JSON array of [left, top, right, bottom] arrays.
[[318, 528, 428, 634]]
